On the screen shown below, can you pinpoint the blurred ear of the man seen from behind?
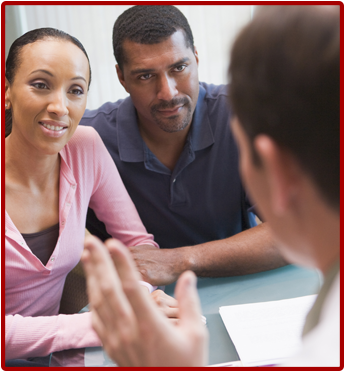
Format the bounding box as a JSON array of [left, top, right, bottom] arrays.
[[253, 135, 300, 216]]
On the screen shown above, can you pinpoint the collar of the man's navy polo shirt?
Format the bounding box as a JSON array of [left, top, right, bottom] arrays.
[[117, 85, 214, 162]]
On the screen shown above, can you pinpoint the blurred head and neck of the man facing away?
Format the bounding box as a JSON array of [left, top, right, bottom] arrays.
[[229, 6, 340, 270]]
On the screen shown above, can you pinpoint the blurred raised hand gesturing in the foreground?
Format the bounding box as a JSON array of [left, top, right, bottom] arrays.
[[82, 236, 208, 367]]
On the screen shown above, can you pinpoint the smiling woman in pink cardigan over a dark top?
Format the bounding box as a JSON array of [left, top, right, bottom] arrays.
[[5, 28, 157, 366]]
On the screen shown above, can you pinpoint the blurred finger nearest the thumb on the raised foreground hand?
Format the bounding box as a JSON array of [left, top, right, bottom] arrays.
[[105, 239, 162, 323]]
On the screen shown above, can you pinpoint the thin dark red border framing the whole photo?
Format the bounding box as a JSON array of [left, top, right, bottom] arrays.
[[1, 0, 344, 371]]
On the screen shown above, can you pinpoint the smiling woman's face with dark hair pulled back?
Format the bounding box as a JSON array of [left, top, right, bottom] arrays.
[[5, 39, 90, 155]]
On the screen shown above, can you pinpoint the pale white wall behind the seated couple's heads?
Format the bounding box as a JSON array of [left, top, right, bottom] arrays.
[[6, 5, 252, 109]]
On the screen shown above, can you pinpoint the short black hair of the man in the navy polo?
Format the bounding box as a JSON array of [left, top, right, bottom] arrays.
[[113, 5, 194, 71]]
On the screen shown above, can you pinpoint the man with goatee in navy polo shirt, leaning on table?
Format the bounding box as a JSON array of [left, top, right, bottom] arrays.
[[81, 6, 285, 285]]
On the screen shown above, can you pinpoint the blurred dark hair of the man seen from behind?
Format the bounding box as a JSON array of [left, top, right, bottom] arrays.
[[229, 5, 340, 211]]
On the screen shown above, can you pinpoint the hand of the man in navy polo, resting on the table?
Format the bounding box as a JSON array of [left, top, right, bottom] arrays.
[[129, 246, 185, 285]]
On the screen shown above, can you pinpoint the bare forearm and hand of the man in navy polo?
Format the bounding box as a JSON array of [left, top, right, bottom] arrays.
[[130, 223, 287, 285]]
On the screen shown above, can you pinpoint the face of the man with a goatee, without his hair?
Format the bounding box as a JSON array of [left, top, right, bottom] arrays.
[[116, 31, 199, 133]]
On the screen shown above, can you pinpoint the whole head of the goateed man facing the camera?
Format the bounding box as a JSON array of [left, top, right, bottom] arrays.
[[113, 5, 199, 133]]
